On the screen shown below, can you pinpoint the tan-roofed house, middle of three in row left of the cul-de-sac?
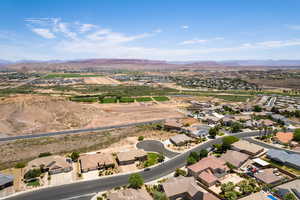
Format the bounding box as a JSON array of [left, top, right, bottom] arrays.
[[78, 153, 115, 172]]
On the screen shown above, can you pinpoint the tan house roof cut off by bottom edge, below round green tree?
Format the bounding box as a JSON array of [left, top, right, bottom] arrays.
[[107, 189, 153, 200]]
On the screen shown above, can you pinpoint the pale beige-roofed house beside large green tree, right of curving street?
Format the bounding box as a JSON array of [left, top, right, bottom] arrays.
[[231, 140, 264, 156]]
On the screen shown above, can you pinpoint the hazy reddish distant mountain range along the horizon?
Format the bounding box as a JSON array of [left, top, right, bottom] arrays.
[[0, 59, 300, 70]]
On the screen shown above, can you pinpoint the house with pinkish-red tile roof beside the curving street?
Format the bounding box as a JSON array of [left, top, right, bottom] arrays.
[[188, 156, 229, 186]]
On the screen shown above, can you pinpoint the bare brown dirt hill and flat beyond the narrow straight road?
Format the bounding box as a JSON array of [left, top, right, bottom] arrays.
[[0, 95, 182, 136]]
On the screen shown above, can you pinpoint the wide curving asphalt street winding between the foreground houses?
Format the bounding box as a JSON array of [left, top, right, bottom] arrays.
[[3, 131, 259, 200]]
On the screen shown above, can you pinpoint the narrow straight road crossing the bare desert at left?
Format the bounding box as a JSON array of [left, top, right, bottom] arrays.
[[0, 120, 164, 142]]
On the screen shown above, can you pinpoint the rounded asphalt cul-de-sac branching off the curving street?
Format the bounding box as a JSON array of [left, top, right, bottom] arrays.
[[136, 140, 179, 158]]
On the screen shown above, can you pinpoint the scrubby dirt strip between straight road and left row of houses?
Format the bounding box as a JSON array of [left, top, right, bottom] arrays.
[[0, 126, 174, 169]]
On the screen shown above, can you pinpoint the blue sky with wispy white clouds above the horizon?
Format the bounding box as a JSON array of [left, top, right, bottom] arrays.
[[0, 0, 300, 61]]
